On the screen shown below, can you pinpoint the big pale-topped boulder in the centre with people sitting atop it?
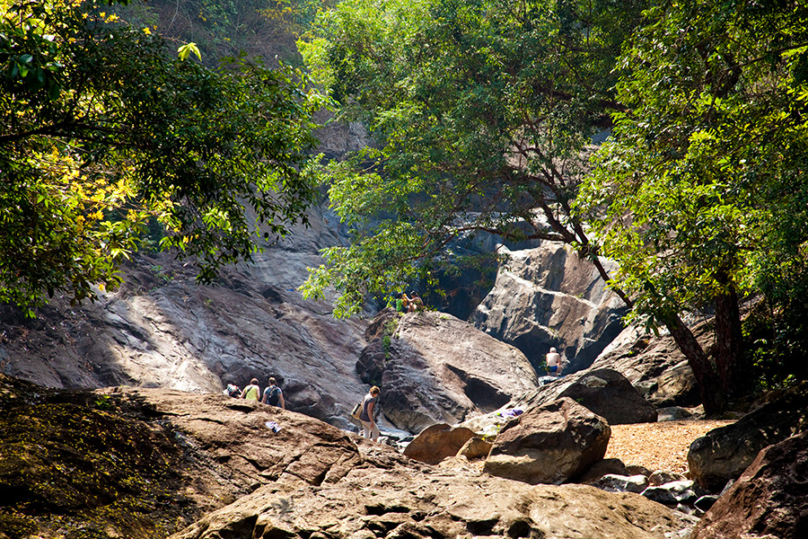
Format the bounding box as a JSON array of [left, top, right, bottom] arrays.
[[356, 312, 538, 432]]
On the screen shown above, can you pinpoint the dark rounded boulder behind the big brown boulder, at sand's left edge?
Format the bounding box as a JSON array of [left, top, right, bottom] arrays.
[[559, 369, 657, 425]]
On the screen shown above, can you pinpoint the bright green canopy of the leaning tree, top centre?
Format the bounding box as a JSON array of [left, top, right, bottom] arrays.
[[299, 0, 641, 316]]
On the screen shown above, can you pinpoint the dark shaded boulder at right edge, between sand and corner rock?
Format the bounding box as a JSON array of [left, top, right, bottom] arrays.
[[687, 384, 808, 492]]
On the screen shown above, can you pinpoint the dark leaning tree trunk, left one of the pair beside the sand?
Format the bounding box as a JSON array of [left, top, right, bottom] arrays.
[[665, 314, 726, 416]]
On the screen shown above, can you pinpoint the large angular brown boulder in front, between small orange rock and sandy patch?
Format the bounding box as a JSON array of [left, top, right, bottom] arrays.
[[483, 397, 611, 485]]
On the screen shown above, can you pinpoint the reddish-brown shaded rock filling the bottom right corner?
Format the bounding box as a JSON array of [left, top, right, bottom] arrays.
[[692, 432, 808, 539]]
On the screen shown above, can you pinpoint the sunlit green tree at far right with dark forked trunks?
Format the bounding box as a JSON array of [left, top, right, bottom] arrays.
[[578, 1, 808, 413]]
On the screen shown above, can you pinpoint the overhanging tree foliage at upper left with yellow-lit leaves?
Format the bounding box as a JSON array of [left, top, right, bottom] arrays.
[[0, 0, 323, 314]]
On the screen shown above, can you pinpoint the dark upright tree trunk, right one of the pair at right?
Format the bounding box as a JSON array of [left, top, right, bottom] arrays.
[[715, 277, 743, 397]]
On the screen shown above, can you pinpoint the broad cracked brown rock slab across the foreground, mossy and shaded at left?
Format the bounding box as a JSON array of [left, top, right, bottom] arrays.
[[0, 376, 690, 539]]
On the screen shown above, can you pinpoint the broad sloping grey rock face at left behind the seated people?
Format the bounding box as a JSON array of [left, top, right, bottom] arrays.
[[0, 201, 374, 427]]
